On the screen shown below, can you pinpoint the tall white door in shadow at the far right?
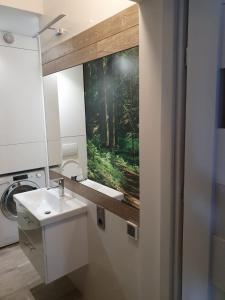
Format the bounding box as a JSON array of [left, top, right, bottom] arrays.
[[182, 0, 225, 300]]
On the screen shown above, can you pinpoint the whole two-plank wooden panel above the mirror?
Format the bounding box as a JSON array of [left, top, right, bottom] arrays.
[[42, 5, 139, 76]]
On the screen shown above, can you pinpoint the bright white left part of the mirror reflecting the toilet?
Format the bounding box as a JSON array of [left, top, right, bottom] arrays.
[[43, 65, 87, 180]]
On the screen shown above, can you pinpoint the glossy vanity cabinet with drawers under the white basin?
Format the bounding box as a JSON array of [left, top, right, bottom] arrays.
[[17, 202, 88, 283]]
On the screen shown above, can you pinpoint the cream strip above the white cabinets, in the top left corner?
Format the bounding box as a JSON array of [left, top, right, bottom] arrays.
[[0, 0, 43, 14]]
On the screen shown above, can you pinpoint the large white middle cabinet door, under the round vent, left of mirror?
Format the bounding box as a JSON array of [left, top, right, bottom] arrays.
[[0, 46, 44, 145]]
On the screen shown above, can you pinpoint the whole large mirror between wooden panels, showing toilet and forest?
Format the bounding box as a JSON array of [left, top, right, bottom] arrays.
[[43, 47, 139, 206]]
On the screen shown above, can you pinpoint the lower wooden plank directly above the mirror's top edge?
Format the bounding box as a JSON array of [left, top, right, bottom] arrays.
[[43, 26, 139, 76]]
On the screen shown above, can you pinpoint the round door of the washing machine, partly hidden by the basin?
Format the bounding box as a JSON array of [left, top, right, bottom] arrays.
[[1, 180, 39, 220]]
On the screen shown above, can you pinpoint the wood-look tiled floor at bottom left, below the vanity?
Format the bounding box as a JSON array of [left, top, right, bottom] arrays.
[[0, 245, 82, 300]]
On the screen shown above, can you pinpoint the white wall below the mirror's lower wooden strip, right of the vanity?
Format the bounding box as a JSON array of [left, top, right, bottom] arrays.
[[70, 200, 139, 300]]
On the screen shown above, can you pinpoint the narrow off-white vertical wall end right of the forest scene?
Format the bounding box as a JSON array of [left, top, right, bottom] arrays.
[[139, 0, 162, 300]]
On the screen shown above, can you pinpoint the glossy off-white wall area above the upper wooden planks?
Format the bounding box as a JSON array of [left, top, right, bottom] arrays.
[[41, 0, 134, 50]]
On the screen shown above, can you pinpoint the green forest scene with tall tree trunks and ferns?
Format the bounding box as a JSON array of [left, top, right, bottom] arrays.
[[84, 47, 139, 205]]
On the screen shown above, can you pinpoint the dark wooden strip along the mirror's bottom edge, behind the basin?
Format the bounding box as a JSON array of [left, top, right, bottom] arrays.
[[50, 171, 139, 225]]
